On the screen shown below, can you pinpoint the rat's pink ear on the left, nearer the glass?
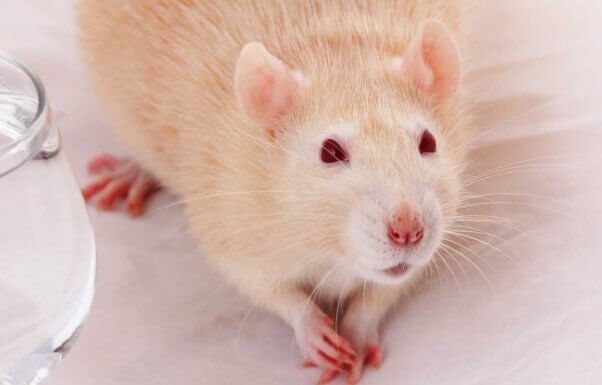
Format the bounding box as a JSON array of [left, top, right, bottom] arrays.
[[234, 42, 300, 127]]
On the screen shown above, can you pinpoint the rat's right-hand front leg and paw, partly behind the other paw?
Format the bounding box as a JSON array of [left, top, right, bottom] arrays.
[[324, 285, 402, 385]]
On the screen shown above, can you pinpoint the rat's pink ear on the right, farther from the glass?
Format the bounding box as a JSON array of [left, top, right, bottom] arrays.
[[395, 19, 460, 101]]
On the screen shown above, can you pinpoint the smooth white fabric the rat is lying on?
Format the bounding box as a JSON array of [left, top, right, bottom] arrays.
[[0, 0, 602, 385]]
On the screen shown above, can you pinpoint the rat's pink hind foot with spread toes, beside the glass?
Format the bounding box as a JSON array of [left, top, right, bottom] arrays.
[[82, 154, 160, 217]]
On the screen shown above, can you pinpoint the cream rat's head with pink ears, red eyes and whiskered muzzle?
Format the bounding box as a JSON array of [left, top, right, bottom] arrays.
[[235, 20, 462, 284]]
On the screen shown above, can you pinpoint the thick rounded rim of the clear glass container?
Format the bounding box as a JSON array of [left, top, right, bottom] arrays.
[[0, 51, 48, 165]]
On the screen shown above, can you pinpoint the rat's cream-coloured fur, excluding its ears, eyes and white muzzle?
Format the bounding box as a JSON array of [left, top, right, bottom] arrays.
[[77, 0, 467, 380]]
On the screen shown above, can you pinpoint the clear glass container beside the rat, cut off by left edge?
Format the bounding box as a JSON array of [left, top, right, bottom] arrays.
[[0, 53, 96, 385]]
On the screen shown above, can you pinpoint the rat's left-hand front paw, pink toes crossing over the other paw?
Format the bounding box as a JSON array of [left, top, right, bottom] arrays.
[[295, 309, 357, 372]]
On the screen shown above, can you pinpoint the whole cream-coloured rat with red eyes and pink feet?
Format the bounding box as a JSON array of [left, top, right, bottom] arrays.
[[77, 0, 469, 384]]
